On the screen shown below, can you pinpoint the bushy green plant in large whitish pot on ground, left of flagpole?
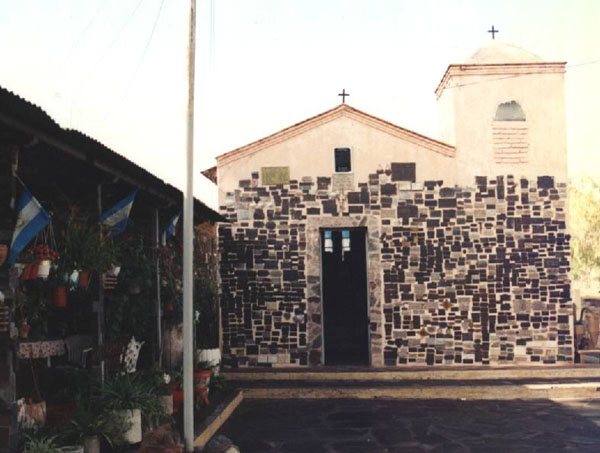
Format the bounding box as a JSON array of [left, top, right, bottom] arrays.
[[102, 374, 163, 444]]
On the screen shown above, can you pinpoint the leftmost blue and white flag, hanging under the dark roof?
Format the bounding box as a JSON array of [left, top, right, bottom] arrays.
[[6, 186, 50, 264]]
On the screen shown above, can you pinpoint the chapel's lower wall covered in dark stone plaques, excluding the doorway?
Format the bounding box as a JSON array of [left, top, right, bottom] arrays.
[[219, 169, 573, 366]]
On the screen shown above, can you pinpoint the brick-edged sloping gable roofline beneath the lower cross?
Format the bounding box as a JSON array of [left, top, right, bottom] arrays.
[[217, 104, 456, 166]]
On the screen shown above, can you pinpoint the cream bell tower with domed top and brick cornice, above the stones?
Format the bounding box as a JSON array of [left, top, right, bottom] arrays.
[[436, 41, 567, 185]]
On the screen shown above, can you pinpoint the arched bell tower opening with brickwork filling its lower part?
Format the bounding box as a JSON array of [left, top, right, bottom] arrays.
[[492, 101, 529, 165]]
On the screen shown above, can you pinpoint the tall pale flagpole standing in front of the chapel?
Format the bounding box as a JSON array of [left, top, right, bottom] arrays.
[[183, 0, 196, 453]]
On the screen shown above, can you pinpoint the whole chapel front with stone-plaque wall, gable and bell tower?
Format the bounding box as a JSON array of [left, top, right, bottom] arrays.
[[216, 42, 574, 367]]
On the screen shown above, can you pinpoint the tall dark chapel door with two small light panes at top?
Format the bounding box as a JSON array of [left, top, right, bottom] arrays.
[[321, 228, 369, 365]]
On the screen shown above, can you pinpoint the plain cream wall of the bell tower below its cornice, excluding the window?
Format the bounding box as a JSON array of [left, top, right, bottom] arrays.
[[439, 66, 567, 184]]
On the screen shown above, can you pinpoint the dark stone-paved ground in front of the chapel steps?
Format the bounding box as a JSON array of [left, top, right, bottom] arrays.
[[219, 399, 600, 453]]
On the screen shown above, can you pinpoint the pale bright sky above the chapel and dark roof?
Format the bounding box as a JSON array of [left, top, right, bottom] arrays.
[[0, 0, 600, 207]]
